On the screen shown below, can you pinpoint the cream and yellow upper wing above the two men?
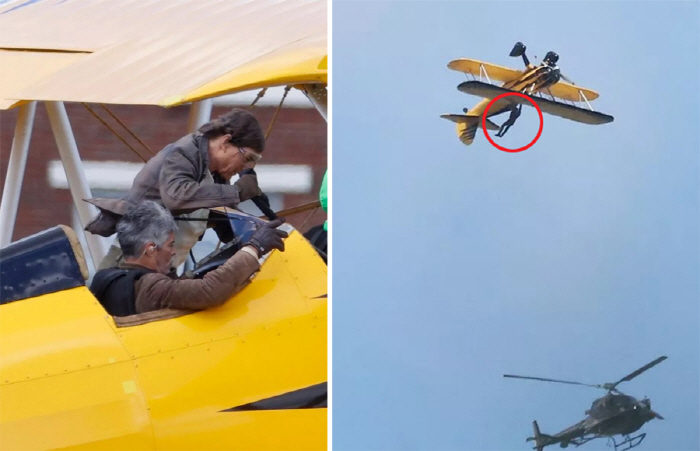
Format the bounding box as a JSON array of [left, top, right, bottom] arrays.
[[0, 0, 328, 108]]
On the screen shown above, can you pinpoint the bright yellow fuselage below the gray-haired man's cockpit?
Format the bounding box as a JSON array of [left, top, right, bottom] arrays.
[[0, 232, 327, 450]]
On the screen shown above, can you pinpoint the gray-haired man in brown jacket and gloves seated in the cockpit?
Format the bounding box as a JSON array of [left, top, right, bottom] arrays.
[[90, 201, 287, 316]]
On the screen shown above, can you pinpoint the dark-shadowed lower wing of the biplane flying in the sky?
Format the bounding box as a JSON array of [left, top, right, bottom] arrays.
[[457, 81, 614, 125]]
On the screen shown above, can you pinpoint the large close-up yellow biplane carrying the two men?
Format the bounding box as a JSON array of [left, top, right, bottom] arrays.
[[0, 0, 328, 451]]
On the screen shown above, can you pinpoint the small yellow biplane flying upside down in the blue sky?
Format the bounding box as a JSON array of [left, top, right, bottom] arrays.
[[440, 42, 614, 146]]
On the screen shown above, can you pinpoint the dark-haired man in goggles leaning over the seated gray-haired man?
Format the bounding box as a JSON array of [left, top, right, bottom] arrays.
[[85, 108, 269, 269]]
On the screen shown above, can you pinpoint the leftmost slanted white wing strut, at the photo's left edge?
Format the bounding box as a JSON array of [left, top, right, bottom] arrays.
[[0, 102, 36, 247]]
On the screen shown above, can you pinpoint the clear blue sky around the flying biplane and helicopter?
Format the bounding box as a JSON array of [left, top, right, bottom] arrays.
[[332, 0, 700, 451]]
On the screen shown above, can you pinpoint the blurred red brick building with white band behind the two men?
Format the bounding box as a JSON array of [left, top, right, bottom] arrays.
[[0, 89, 327, 268]]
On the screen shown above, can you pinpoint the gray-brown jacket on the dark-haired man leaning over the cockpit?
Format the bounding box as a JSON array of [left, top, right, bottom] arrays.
[[85, 133, 241, 237]]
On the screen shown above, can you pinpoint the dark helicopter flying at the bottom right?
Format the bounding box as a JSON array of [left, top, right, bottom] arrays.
[[503, 356, 667, 451]]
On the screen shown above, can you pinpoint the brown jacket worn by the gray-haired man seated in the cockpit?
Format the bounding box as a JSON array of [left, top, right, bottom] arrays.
[[119, 251, 260, 313]]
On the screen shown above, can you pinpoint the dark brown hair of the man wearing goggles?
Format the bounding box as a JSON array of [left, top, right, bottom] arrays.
[[199, 108, 265, 153]]
